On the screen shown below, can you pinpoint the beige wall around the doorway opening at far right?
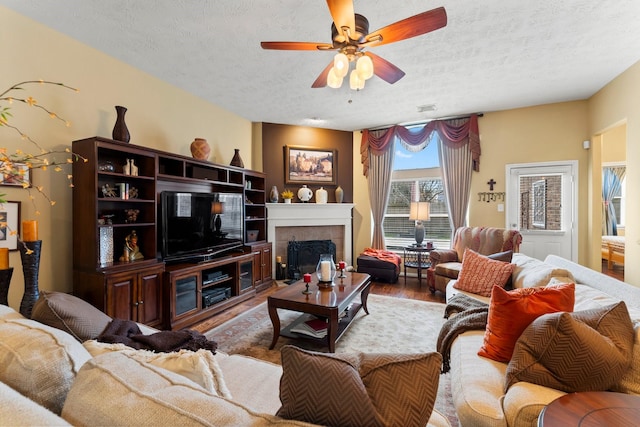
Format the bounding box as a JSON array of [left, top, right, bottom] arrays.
[[589, 62, 640, 286]]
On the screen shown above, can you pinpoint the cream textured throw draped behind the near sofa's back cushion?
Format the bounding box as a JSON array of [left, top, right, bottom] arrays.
[[82, 340, 231, 399]]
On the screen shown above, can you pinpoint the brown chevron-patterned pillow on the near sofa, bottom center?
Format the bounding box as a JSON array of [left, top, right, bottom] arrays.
[[276, 346, 442, 427]]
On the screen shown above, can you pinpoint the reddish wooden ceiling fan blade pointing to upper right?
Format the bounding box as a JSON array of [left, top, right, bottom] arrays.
[[366, 7, 447, 46]]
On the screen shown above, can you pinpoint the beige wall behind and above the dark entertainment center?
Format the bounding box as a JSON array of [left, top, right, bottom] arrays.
[[0, 7, 252, 308]]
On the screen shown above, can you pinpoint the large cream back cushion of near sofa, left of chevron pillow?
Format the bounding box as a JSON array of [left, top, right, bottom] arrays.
[[62, 352, 308, 427]]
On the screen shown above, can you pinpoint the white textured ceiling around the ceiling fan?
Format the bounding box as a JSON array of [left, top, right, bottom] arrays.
[[0, 0, 640, 130]]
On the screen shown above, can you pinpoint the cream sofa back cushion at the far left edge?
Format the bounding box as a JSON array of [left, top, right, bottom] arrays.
[[0, 318, 91, 414]]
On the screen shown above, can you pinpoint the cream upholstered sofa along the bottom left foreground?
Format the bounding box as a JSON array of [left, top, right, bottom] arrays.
[[0, 292, 450, 426]]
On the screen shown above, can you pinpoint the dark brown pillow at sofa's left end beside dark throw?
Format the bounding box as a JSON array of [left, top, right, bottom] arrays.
[[31, 291, 111, 342]]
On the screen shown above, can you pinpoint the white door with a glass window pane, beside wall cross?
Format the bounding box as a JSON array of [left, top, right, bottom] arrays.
[[506, 160, 578, 261]]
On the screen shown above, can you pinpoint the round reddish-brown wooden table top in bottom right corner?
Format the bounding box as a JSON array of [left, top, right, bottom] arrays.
[[538, 391, 640, 427]]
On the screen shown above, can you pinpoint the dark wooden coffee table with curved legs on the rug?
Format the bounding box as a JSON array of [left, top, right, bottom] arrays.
[[267, 272, 371, 353]]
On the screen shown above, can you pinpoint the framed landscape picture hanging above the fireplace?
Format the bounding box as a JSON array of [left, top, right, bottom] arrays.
[[284, 145, 337, 185]]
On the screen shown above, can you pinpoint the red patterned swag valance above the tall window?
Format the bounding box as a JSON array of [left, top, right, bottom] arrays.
[[360, 114, 480, 176]]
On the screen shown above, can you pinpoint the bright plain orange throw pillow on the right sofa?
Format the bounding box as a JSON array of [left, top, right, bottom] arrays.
[[478, 283, 576, 362]]
